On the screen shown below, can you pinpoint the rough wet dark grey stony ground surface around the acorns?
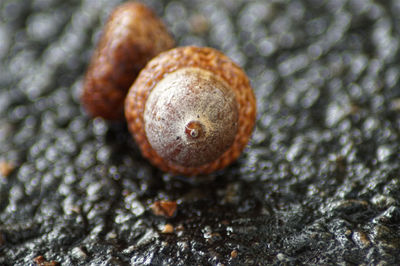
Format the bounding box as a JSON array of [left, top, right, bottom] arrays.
[[0, 0, 400, 265]]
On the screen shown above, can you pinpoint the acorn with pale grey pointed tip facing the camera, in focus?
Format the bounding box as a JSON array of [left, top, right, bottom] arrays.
[[125, 46, 256, 176]]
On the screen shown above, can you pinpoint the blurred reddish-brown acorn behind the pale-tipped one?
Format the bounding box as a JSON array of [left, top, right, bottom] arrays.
[[82, 2, 174, 120]]
